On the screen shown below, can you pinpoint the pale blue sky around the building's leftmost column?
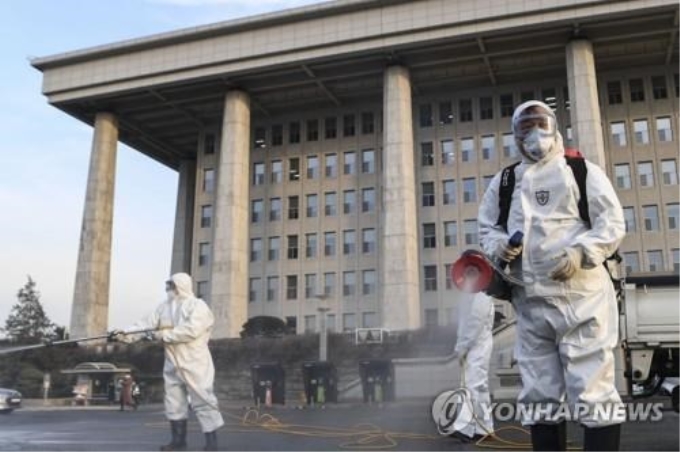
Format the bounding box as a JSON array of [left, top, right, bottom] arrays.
[[0, 0, 320, 328]]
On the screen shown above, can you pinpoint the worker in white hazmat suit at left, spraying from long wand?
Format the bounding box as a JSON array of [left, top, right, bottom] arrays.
[[109, 273, 224, 451]]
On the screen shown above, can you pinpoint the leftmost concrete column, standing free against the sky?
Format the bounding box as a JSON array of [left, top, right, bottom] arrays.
[[70, 113, 118, 338]]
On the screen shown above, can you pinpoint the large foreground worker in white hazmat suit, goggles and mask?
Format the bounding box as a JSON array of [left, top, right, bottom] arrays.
[[478, 101, 625, 450]]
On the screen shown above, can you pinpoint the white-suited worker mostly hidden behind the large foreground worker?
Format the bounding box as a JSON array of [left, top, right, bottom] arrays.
[[454, 292, 495, 442]]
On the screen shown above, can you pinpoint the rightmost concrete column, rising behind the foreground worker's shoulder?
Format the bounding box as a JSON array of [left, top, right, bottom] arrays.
[[567, 39, 606, 168]]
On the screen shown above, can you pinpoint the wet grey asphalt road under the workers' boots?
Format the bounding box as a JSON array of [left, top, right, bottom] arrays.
[[0, 400, 679, 451]]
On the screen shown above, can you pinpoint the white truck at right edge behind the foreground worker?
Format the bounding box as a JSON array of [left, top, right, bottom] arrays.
[[619, 274, 680, 412]]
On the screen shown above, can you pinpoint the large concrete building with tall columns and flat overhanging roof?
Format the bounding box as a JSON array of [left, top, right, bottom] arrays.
[[32, 0, 680, 337]]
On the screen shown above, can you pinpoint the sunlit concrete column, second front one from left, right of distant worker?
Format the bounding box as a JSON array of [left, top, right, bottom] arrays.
[[210, 91, 250, 338]]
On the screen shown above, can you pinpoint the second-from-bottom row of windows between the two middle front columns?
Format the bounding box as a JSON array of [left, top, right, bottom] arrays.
[[248, 269, 378, 303]]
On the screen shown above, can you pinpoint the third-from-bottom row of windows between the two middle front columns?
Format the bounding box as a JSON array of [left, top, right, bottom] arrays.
[[248, 228, 377, 262]]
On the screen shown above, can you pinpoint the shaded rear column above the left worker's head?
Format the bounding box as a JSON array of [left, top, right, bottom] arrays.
[[170, 160, 196, 274]]
